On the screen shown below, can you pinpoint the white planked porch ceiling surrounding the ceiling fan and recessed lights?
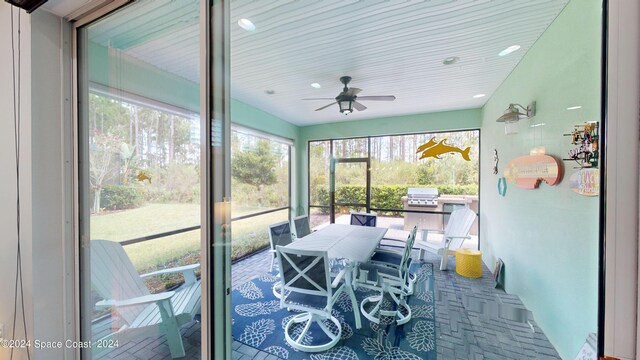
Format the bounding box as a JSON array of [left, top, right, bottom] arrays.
[[52, 0, 569, 125]]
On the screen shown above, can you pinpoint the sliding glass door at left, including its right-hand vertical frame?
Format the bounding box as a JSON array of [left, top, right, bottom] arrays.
[[76, 0, 231, 359]]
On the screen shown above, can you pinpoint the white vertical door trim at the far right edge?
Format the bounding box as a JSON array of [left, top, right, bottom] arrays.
[[598, 0, 640, 359]]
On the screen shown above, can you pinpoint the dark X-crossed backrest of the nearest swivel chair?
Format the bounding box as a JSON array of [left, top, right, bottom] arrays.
[[276, 246, 331, 301]]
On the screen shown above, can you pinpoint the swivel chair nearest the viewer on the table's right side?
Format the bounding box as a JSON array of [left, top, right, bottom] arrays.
[[355, 227, 417, 325]]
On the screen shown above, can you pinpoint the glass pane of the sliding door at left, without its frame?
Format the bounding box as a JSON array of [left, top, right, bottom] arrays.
[[78, 0, 202, 359]]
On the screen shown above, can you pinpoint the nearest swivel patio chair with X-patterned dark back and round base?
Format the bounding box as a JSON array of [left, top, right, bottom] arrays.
[[276, 246, 358, 352]]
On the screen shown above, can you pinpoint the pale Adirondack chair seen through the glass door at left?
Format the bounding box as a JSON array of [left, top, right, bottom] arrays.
[[91, 240, 201, 358]]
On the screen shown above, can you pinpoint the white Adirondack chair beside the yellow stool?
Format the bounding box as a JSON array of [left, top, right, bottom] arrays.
[[418, 208, 476, 270]]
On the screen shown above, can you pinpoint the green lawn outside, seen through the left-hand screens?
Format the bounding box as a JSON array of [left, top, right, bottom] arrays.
[[91, 204, 287, 272]]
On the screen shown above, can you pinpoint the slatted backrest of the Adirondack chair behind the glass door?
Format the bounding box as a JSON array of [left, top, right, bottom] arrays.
[[90, 240, 150, 324]]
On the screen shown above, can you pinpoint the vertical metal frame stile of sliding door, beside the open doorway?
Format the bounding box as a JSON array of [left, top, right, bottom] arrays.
[[200, 0, 231, 360]]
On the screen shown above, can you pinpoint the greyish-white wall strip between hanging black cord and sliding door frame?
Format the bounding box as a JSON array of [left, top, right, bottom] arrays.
[[31, 10, 75, 359]]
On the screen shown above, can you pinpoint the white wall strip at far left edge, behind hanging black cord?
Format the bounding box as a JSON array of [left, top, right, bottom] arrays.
[[0, 1, 33, 359]]
